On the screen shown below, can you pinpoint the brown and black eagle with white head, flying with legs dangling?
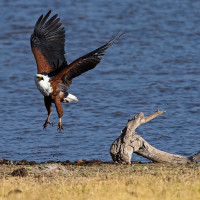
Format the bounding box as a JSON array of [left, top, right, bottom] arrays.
[[30, 10, 121, 131]]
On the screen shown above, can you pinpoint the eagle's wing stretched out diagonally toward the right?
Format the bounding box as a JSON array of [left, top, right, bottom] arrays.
[[53, 33, 123, 89]]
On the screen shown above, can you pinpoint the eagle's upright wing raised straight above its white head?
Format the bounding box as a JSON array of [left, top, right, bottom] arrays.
[[30, 10, 67, 73]]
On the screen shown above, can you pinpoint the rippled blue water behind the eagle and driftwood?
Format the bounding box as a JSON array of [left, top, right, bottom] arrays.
[[0, 0, 200, 161]]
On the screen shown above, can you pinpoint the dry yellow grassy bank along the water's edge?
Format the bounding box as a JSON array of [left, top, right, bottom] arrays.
[[0, 164, 200, 200]]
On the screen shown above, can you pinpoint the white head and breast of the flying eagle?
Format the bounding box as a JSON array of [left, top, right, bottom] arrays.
[[35, 74, 53, 96]]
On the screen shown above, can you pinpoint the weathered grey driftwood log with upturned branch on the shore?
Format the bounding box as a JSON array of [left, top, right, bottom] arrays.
[[110, 110, 200, 164]]
